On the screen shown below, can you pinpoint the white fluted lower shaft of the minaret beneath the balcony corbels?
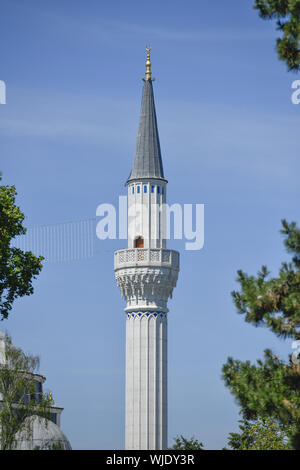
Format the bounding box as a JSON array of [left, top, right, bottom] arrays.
[[125, 311, 167, 450]]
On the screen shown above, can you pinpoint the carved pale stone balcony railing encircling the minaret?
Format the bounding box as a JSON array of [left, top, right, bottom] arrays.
[[114, 248, 179, 271]]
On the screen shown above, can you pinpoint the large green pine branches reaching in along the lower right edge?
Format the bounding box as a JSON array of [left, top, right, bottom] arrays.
[[222, 220, 300, 449]]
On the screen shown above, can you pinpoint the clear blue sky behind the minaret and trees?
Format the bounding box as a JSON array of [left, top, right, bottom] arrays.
[[0, 0, 300, 449]]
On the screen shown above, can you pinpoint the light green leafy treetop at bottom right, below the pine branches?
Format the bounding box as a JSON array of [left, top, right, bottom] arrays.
[[228, 417, 294, 450]]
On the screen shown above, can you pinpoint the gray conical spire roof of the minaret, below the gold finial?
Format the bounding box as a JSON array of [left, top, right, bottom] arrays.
[[127, 57, 165, 183]]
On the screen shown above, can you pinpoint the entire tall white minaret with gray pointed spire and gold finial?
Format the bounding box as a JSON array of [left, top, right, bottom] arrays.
[[114, 48, 179, 450]]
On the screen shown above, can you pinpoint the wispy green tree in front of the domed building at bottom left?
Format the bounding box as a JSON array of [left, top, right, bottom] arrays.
[[0, 335, 51, 450]]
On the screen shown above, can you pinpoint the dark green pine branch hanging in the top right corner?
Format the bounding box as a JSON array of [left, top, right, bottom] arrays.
[[254, 0, 300, 71]]
